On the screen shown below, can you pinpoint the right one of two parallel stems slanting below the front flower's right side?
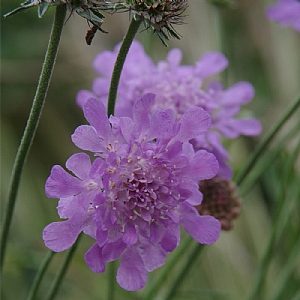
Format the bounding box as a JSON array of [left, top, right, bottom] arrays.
[[164, 244, 205, 300]]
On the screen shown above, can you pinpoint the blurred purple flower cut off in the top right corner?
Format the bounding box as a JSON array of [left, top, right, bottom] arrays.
[[267, 0, 300, 31]]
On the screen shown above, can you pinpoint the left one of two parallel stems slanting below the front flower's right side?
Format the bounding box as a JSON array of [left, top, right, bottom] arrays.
[[144, 236, 193, 300]]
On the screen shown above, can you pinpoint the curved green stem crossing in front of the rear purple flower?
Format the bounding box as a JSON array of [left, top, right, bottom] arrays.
[[107, 19, 141, 116]]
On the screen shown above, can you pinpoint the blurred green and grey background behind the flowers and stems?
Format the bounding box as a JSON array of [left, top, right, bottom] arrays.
[[1, 0, 300, 300]]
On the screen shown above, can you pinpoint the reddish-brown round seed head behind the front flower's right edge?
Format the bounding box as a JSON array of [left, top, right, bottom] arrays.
[[196, 177, 241, 230]]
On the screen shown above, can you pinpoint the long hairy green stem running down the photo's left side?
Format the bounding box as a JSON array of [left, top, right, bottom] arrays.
[[0, 5, 67, 268]]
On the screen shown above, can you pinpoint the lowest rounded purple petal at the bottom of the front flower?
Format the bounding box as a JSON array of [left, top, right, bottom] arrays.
[[117, 247, 148, 291]]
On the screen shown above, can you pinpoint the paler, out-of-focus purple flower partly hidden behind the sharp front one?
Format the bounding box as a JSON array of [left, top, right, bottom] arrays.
[[77, 41, 261, 179]]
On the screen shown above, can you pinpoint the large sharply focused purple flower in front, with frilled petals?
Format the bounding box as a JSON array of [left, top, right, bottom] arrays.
[[43, 94, 220, 291]]
